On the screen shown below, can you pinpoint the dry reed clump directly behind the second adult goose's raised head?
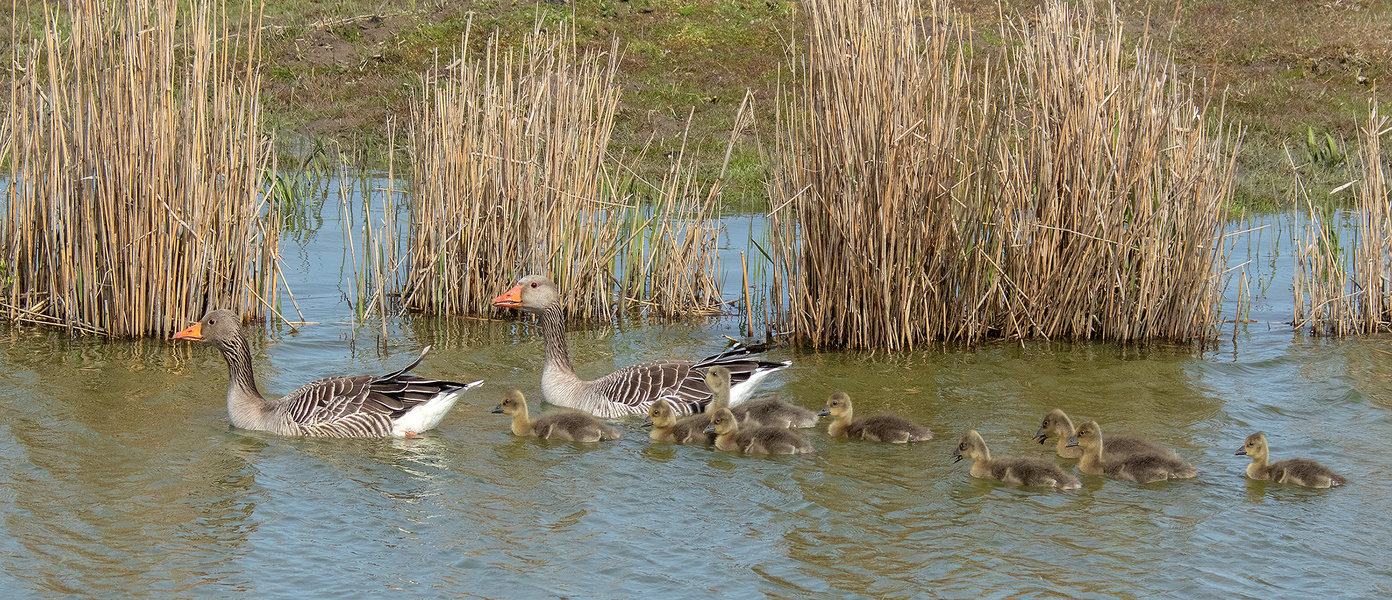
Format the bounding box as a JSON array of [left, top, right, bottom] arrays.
[[404, 20, 720, 319]]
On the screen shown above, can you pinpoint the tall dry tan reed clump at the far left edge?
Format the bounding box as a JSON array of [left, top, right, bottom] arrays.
[[0, 0, 278, 337]]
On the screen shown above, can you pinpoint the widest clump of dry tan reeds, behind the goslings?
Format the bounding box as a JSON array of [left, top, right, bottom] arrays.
[[770, 0, 1236, 349]]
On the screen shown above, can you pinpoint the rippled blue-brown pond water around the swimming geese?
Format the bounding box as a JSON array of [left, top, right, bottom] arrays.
[[0, 203, 1392, 599]]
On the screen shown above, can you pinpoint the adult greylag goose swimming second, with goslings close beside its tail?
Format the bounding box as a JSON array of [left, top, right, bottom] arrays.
[[493, 276, 791, 419]]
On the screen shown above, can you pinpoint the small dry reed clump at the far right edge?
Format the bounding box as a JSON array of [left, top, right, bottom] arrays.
[[1293, 96, 1392, 335]]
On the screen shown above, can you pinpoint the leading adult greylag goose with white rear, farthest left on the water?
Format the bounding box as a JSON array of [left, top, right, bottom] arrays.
[[174, 309, 483, 437]]
